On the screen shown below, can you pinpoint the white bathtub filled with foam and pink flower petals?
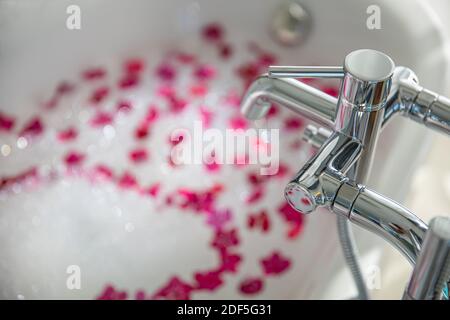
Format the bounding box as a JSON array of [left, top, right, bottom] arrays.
[[0, 0, 449, 299]]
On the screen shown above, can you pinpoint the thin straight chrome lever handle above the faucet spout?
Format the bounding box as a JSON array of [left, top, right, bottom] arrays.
[[269, 66, 344, 79]]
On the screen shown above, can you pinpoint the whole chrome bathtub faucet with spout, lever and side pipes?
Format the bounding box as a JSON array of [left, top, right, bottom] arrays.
[[241, 49, 450, 299]]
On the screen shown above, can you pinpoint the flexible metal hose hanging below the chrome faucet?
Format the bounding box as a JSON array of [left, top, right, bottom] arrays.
[[337, 216, 369, 300]]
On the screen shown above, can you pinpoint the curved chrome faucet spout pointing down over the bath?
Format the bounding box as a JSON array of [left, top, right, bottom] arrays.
[[241, 74, 337, 128]]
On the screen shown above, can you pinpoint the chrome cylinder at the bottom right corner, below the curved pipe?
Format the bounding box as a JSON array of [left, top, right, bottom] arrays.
[[405, 217, 450, 300]]
